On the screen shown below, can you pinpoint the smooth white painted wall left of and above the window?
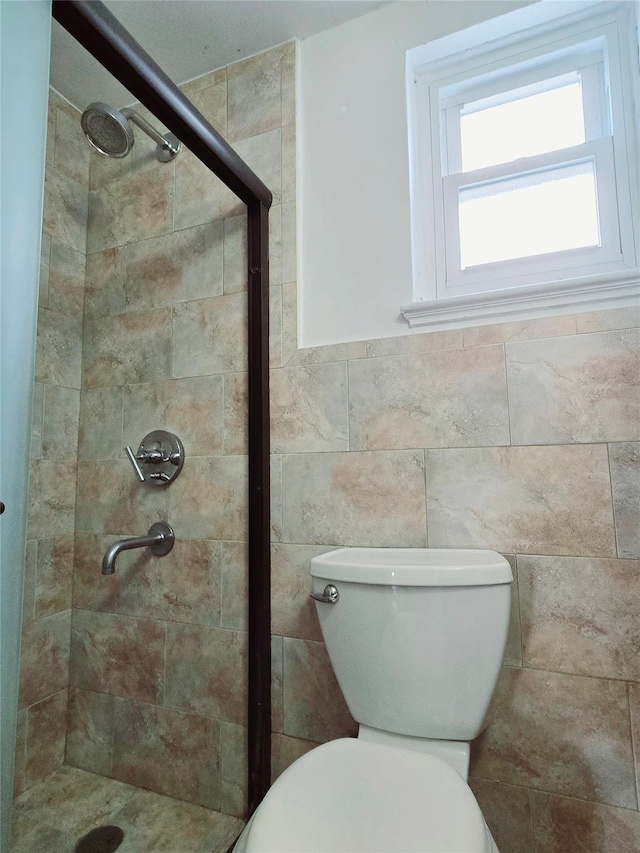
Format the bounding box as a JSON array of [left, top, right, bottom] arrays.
[[298, 0, 526, 347]]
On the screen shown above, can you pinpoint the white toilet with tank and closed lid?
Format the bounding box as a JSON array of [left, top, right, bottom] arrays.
[[234, 548, 513, 853]]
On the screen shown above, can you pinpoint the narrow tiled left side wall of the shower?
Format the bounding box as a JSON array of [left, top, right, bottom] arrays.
[[15, 90, 89, 793]]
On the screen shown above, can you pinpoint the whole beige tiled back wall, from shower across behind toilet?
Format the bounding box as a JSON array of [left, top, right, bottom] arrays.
[[15, 33, 640, 853]]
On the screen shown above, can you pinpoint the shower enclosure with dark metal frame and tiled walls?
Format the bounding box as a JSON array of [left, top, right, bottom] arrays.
[[7, 2, 278, 844]]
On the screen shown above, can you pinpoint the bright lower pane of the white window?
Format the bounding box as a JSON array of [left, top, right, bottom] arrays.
[[458, 161, 600, 269]]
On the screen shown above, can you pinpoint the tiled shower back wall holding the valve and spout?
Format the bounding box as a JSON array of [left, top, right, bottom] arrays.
[[66, 45, 295, 815]]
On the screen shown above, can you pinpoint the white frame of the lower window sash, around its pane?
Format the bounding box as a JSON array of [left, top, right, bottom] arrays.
[[436, 137, 622, 298]]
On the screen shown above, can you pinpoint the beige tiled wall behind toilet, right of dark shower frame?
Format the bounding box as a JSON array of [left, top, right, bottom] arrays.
[[272, 284, 640, 853]]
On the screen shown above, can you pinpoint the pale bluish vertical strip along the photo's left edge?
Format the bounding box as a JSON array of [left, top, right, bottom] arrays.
[[0, 0, 51, 853]]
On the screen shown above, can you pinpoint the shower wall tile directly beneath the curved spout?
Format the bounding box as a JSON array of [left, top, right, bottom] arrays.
[[118, 538, 220, 626]]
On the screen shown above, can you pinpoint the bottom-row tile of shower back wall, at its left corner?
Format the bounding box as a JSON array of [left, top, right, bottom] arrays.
[[65, 687, 114, 776]]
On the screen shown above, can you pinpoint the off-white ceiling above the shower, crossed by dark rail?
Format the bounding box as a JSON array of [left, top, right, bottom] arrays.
[[51, 0, 386, 110]]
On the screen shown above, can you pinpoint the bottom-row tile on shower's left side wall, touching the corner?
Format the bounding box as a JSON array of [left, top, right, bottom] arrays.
[[25, 689, 67, 786]]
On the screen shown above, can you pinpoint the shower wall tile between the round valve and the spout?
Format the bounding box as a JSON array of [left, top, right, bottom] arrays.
[[76, 459, 170, 536]]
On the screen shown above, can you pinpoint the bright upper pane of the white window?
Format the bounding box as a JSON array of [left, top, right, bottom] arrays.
[[460, 81, 585, 172]]
